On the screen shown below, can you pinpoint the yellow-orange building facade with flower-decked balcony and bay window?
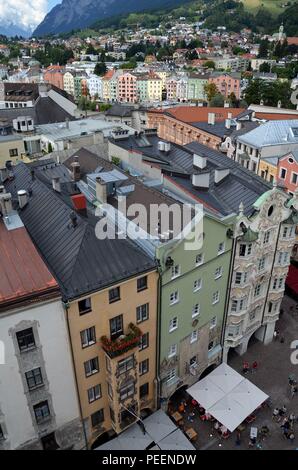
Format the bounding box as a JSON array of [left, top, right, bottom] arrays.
[[67, 271, 157, 446]]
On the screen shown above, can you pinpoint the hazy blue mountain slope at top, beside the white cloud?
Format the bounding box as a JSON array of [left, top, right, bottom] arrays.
[[33, 0, 187, 36]]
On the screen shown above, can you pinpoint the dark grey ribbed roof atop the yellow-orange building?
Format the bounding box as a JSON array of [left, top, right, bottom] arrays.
[[6, 163, 155, 300]]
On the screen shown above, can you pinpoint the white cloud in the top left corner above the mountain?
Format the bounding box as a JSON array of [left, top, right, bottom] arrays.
[[0, 0, 48, 31]]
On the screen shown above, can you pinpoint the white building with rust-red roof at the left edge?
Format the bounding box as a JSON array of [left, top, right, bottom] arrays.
[[0, 196, 85, 450]]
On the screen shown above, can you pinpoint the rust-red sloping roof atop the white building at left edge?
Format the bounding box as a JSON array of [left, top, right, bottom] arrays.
[[0, 222, 59, 308]]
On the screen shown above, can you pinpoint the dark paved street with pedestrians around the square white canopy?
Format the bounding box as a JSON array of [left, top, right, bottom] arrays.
[[170, 297, 298, 450]]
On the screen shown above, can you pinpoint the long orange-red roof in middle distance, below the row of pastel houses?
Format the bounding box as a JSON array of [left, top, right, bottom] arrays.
[[165, 106, 244, 122]]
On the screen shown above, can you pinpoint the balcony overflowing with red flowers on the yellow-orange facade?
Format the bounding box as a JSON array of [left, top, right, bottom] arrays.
[[101, 323, 142, 358]]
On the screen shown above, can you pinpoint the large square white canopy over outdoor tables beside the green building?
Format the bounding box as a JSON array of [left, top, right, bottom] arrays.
[[187, 363, 268, 432]]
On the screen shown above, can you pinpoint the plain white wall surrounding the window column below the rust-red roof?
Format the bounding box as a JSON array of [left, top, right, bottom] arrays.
[[0, 300, 79, 448]]
